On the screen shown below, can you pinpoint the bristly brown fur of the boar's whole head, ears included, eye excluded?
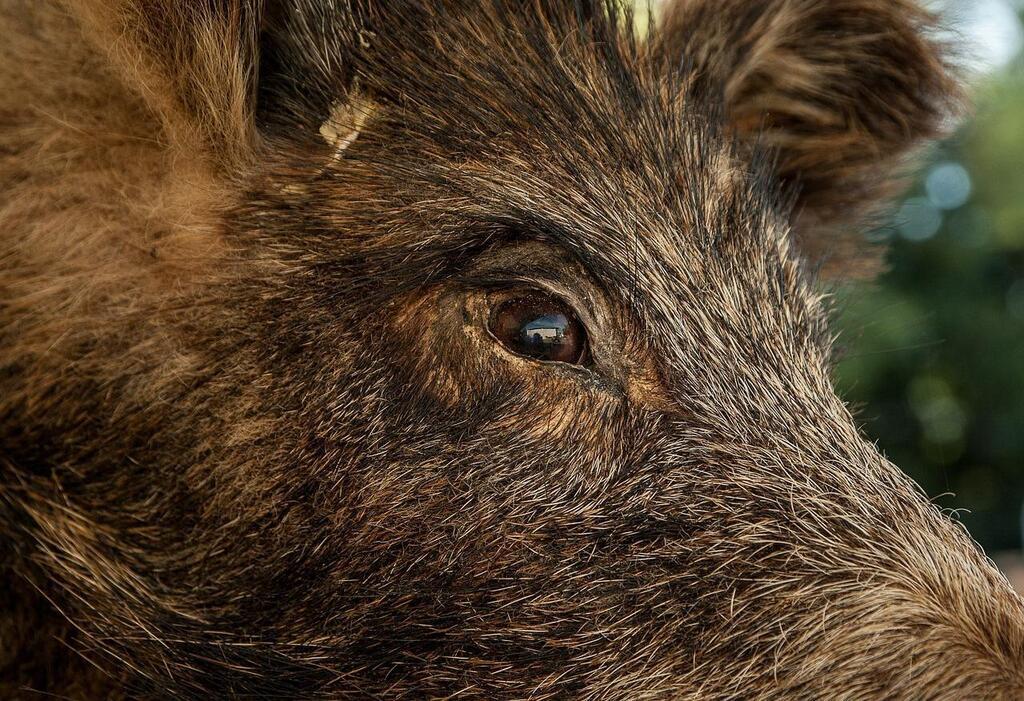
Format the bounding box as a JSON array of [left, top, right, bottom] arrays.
[[0, 0, 1024, 699]]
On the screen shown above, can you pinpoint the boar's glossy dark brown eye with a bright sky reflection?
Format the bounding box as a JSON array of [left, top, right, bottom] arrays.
[[487, 293, 587, 364]]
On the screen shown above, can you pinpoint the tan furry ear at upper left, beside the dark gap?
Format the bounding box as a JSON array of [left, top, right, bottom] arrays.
[[66, 0, 261, 167]]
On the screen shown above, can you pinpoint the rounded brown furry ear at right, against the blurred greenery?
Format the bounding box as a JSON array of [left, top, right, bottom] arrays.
[[650, 0, 963, 275]]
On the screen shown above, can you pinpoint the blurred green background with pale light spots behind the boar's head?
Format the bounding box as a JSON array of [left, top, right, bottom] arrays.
[[638, 0, 1024, 593]]
